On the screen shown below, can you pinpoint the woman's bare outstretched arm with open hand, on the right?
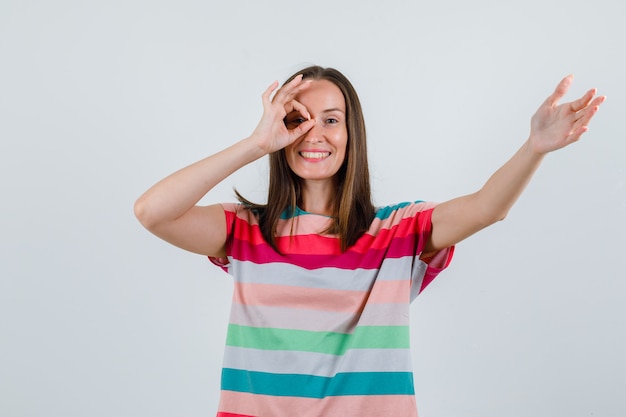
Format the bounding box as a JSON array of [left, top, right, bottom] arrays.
[[425, 75, 605, 252]]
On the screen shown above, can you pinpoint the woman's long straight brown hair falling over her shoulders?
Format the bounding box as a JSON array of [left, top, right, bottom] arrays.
[[235, 66, 376, 251]]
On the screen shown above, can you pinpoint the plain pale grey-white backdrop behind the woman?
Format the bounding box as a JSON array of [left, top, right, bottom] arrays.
[[0, 0, 626, 417]]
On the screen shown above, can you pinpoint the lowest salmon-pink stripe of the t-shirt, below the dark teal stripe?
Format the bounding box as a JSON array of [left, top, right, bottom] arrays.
[[218, 391, 417, 417]]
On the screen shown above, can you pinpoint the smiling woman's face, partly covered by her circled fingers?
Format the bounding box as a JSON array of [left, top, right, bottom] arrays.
[[285, 80, 348, 184]]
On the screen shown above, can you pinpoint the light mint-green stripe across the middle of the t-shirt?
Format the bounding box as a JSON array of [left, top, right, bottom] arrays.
[[226, 324, 410, 355]]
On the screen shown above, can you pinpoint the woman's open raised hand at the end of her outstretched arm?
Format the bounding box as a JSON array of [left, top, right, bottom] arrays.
[[529, 75, 606, 154]]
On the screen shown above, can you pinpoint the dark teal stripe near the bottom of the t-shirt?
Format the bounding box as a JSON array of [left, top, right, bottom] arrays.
[[222, 368, 415, 398]]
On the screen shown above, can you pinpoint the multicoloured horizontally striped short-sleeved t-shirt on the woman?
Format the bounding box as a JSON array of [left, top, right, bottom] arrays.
[[211, 202, 454, 417]]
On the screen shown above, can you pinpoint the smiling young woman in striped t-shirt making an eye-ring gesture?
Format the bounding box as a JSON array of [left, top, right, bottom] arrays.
[[135, 67, 604, 417]]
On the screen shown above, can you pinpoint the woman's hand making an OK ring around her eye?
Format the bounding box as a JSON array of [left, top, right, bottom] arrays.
[[250, 75, 315, 154]]
